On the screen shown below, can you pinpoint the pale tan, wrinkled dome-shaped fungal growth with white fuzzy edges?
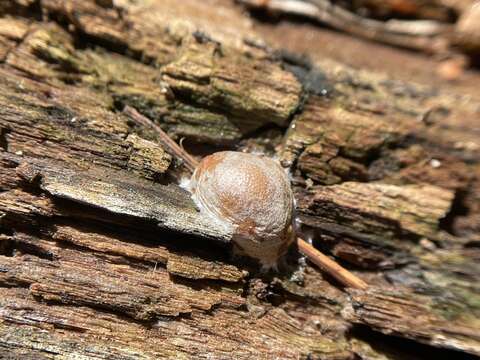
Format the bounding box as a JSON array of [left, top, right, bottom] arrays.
[[189, 151, 293, 267]]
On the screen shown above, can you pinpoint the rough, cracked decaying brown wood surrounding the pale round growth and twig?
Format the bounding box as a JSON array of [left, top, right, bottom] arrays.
[[0, 0, 480, 359]]
